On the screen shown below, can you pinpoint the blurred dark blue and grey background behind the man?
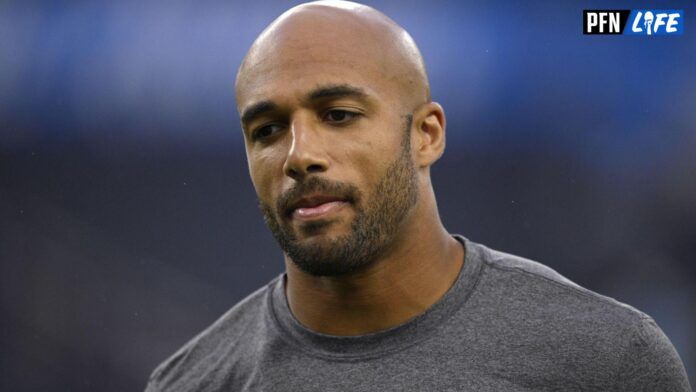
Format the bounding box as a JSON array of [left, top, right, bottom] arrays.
[[0, 0, 696, 392]]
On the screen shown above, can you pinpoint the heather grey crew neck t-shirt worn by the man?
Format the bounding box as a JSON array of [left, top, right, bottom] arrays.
[[147, 235, 691, 392]]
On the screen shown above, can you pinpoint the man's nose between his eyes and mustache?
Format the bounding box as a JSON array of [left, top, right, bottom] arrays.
[[283, 116, 329, 181]]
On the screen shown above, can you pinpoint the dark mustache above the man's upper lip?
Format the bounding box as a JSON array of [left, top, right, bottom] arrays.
[[276, 177, 362, 217]]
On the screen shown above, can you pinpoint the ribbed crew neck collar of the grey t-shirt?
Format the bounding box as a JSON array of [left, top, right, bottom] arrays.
[[268, 234, 482, 360]]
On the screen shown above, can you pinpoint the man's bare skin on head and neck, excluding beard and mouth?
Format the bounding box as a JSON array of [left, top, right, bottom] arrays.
[[236, 1, 464, 336]]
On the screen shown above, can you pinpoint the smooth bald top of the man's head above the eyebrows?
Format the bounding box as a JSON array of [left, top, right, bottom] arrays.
[[236, 1, 430, 111]]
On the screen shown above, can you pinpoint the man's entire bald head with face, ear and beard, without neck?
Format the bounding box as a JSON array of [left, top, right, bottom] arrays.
[[236, 1, 448, 276]]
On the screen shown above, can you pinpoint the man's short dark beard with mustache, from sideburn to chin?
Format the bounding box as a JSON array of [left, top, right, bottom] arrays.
[[259, 115, 418, 276]]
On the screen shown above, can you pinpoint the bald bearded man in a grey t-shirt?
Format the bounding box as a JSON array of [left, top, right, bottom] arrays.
[[147, 2, 690, 392]]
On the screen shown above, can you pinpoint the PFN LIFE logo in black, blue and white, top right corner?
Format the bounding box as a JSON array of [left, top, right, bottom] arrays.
[[582, 9, 684, 36]]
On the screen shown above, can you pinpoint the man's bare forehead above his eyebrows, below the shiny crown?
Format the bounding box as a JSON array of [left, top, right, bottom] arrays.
[[236, 23, 394, 109]]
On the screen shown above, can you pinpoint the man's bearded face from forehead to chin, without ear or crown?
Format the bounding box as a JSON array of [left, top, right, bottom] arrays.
[[237, 21, 418, 276]]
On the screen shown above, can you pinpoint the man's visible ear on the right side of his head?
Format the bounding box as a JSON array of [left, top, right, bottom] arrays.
[[411, 102, 445, 167]]
